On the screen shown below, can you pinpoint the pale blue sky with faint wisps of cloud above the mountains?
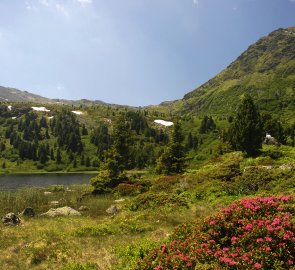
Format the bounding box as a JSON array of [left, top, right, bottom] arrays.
[[0, 0, 295, 106]]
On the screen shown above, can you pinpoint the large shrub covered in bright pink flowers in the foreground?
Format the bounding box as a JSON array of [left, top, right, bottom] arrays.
[[136, 195, 295, 270]]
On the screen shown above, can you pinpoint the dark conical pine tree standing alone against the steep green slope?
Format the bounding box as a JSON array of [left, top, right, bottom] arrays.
[[229, 95, 264, 156]]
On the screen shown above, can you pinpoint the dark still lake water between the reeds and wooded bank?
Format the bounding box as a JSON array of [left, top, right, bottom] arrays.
[[0, 173, 96, 190]]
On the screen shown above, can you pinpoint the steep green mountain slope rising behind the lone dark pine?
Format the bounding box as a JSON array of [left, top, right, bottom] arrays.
[[173, 27, 295, 119]]
